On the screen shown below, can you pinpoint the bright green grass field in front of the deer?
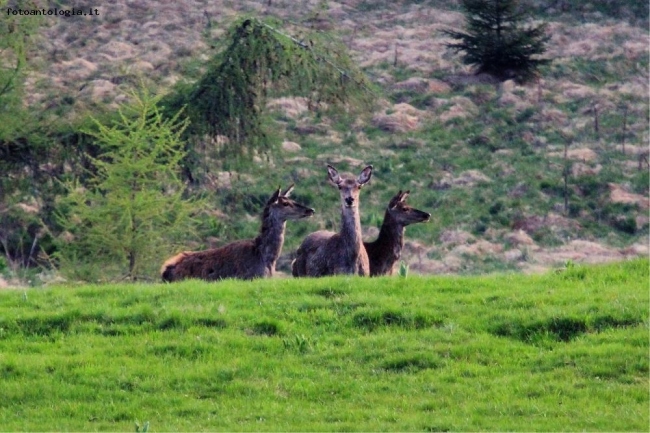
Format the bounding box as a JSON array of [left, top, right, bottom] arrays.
[[0, 260, 650, 431]]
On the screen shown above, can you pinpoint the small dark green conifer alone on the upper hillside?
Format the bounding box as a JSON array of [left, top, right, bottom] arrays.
[[443, 0, 550, 83]]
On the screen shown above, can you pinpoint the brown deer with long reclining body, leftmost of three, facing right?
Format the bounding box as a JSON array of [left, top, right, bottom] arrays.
[[160, 185, 314, 282]]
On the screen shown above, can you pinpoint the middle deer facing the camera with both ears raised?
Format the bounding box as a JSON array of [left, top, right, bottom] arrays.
[[292, 165, 372, 277]]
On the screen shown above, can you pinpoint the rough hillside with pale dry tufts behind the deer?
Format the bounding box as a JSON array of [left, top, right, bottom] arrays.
[[2, 0, 650, 282]]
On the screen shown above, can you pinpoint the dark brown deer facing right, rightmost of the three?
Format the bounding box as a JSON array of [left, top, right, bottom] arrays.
[[363, 191, 431, 277]]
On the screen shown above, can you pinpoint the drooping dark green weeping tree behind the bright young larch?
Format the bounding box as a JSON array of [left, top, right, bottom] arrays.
[[161, 18, 369, 170]]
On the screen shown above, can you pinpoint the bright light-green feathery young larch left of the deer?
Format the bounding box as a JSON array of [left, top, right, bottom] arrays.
[[56, 90, 200, 280]]
